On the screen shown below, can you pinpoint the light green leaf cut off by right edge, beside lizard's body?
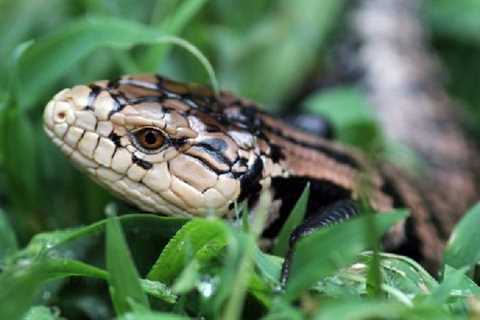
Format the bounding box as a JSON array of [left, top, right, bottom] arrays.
[[444, 204, 480, 269]]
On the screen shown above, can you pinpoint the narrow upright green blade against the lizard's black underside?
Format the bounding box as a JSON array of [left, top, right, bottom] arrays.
[[273, 184, 310, 256]]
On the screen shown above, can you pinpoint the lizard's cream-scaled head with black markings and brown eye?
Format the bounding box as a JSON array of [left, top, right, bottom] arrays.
[[44, 76, 262, 216]]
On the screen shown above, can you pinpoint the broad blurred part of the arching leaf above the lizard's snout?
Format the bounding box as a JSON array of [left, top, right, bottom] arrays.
[[17, 17, 164, 108]]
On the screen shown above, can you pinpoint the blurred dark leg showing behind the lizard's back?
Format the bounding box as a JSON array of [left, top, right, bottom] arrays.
[[283, 114, 335, 140]]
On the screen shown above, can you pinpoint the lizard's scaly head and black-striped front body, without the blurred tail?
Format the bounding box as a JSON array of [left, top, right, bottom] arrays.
[[43, 75, 450, 282]]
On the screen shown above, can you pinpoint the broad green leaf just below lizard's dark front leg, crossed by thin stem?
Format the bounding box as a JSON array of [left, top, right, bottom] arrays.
[[286, 210, 407, 299]]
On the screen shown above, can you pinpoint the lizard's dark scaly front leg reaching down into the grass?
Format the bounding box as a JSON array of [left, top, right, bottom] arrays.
[[280, 200, 358, 287]]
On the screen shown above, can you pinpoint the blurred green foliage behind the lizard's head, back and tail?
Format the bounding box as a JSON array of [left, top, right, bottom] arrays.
[[0, 0, 480, 262]]
